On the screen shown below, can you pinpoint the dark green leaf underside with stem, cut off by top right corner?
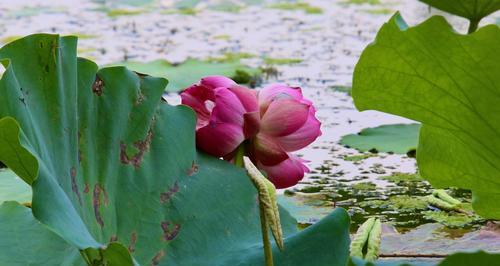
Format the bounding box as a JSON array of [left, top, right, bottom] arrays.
[[420, 0, 500, 21]]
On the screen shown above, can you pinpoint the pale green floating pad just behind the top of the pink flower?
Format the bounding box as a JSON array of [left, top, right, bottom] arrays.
[[114, 59, 258, 92]]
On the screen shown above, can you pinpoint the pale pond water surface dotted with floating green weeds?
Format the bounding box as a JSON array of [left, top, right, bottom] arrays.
[[0, 0, 500, 262]]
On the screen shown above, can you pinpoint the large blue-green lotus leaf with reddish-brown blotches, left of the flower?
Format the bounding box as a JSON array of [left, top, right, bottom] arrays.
[[0, 34, 349, 265]]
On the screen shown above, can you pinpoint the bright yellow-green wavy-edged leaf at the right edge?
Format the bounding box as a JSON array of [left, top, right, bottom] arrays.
[[353, 15, 500, 219]]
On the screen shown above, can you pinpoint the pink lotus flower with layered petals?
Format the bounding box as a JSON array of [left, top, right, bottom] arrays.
[[181, 76, 321, 188]]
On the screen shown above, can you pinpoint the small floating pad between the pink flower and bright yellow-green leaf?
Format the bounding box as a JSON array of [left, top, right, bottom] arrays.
[[340, 124, 420, 154]]
